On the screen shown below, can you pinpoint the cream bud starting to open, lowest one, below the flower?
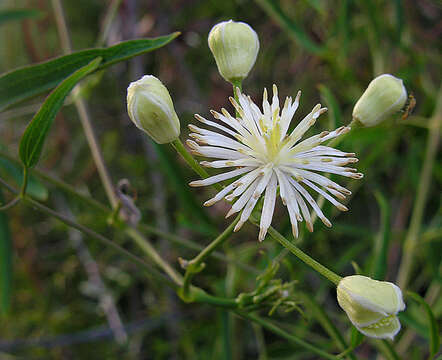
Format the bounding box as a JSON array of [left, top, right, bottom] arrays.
[[337, 275, 405, 339]]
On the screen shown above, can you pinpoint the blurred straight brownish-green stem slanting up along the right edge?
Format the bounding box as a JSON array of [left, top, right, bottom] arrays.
[[397, 88, 442, 291]]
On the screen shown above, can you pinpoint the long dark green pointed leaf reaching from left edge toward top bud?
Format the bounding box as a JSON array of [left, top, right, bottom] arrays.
[[0, 32, 179, 111]]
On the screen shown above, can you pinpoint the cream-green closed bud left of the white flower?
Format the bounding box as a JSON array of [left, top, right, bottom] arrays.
[[127, 75, 180, 144]]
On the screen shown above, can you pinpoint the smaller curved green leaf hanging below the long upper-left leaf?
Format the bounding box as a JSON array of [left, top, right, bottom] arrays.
[[19, 58, 101, 168]]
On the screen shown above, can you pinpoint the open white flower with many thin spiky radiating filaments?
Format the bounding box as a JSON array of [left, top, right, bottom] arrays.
[[187, 85, 363, 241]]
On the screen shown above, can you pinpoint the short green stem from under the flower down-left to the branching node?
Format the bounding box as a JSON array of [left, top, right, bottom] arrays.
[[182, 215, 240, 297]]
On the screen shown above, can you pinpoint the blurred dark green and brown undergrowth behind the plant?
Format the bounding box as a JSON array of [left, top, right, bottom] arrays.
[[0, 0, 442, 359]]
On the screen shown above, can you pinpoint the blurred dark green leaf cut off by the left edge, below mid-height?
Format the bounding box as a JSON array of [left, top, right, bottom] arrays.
[[0, 189, 13, 314]]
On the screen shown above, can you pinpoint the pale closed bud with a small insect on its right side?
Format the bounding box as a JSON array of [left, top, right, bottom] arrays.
[[353, 74, 407, 127]]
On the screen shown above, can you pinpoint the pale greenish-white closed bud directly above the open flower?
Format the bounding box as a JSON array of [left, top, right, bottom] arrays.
[[208, 20, 259, 82]]
